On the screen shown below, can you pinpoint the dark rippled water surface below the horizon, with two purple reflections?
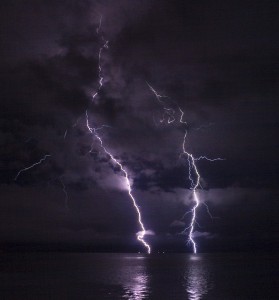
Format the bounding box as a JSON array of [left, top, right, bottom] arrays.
[[0, 253, 279, 300]]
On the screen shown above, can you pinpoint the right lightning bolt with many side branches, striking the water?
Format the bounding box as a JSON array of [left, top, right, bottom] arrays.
[[146, 82, 224, 254]]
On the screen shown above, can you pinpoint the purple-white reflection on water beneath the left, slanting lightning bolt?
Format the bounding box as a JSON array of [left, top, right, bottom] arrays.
[[122, 257, 149, 300]]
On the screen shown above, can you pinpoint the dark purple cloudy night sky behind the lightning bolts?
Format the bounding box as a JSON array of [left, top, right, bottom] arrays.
[[0, 0, 279, 252]]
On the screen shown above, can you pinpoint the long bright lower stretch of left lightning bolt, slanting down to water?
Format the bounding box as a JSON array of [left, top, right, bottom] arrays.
[[86, 111, 151, 254]]
